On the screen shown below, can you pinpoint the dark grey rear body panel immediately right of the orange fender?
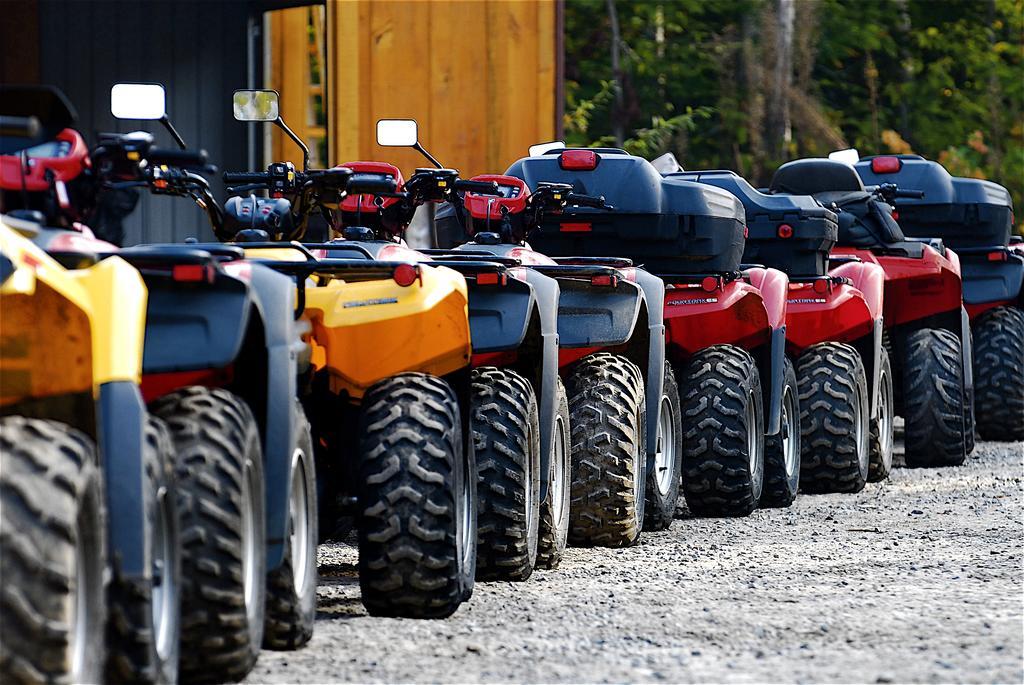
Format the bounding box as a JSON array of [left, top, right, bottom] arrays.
[[467, 276, 537, 352]]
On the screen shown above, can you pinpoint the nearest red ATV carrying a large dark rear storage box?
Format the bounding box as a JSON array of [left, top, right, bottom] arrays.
[[506, 147, 798, 516]]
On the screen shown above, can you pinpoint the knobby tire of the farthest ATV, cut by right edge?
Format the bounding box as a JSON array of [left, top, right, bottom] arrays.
[[974, 307, 1024, 441]]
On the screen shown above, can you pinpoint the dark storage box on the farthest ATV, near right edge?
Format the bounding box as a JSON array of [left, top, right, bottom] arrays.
[[856, 155, 1013, 250]]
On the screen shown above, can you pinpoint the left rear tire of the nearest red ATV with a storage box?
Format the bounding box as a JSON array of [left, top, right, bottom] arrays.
[[682, 345, 764, 516]]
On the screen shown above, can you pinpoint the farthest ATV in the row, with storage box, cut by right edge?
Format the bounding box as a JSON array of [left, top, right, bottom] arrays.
[[854, 155, 1024, 440]]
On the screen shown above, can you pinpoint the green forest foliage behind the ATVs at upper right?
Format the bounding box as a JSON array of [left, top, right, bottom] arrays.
[[565, 0, 1024, 232]]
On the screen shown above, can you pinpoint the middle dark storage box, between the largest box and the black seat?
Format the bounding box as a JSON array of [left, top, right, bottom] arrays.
[[668, 171, 839, 276]]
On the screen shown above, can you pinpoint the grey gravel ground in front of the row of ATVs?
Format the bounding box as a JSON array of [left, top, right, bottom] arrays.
[[249, 442, 1024, 683]]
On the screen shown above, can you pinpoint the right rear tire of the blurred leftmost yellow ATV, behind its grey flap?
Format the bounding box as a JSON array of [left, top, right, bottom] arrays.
[[106, 417, 181, 683]]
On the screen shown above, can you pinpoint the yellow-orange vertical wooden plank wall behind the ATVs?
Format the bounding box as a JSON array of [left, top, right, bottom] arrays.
[[327, 0, 557, 178]]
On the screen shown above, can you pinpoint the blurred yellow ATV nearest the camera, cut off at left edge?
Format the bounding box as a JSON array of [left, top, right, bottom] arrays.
[[0, 97, 180, 683]]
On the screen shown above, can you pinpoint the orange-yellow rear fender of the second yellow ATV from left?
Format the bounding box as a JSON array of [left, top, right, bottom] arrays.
[[304, 266, 471, 399]]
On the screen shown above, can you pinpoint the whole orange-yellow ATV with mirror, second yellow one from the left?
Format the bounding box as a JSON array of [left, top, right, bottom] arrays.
[[207, 91, 483, 617]]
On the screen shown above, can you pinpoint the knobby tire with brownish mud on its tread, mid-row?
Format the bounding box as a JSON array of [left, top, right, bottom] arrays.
[[566, 352, 647, 547]]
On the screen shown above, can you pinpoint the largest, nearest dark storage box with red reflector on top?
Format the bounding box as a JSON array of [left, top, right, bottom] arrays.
[[506, 148, 743, 274]]
